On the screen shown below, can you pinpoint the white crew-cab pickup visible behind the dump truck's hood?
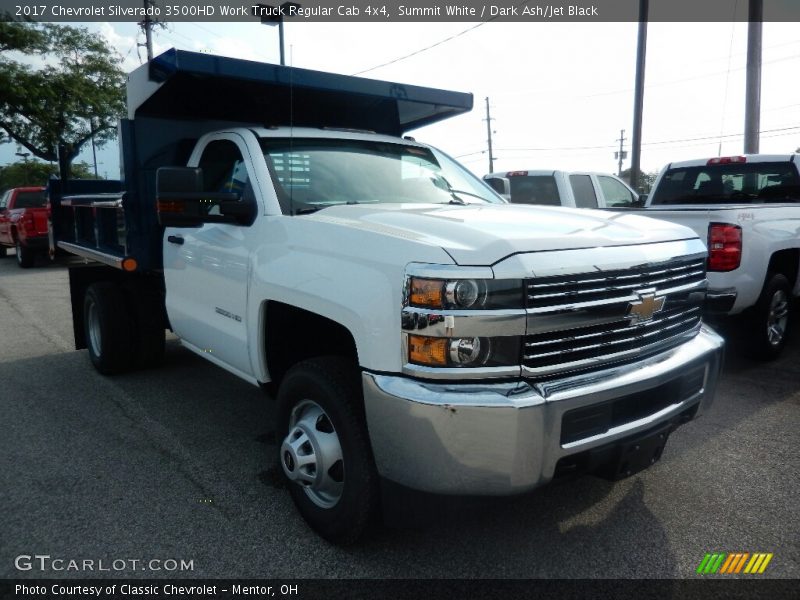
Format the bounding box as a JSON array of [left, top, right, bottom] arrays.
[[483, 169, 639, 208]]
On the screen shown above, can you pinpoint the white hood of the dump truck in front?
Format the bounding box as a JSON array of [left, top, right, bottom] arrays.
[[312, 204, 697, 265]]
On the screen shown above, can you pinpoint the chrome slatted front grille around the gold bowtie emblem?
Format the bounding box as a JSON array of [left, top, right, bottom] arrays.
[[522, 258, 706, 378]]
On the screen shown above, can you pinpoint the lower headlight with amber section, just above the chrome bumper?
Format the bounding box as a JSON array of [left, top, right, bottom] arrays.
[[408, 335, 521, 367]]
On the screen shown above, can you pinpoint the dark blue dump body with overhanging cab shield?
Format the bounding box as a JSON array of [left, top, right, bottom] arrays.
[[50, 49, 472, 272]]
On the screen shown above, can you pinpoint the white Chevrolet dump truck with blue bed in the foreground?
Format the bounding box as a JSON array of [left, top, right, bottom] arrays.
[[51, 51, 722, 543]]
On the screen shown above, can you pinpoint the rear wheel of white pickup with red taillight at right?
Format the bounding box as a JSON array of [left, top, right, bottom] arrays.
[[746, 273, 792, 360]]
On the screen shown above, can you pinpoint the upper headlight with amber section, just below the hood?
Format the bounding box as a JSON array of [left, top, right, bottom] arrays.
[[406, 277, 524, 310]]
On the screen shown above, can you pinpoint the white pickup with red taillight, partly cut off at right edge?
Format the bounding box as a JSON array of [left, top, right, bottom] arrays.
[[640, 154, 800, 358]]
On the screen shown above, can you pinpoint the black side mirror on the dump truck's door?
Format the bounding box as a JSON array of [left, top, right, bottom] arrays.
[[156, 167, 256, 227]]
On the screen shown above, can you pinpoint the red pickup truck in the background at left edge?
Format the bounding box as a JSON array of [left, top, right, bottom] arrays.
[[0, 187, 50, 269]]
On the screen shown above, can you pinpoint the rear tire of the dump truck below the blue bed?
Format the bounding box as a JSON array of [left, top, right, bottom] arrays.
[[83, 282, 134, 375]]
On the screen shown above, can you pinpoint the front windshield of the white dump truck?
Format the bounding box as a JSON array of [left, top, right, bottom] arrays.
[[261, 138, 503, 215]]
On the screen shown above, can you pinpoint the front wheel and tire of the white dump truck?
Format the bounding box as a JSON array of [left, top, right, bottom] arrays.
[[277, 357, 380, 544]]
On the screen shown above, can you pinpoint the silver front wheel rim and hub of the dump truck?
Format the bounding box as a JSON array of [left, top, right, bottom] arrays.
[[280, 400, 344, 508]]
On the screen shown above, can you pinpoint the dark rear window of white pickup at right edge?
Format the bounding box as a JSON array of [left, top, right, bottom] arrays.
[[650, 162, 800, 205]]
